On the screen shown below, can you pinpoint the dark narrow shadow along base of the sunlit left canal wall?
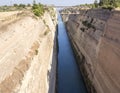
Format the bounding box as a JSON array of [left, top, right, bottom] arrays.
[[47, 25, 58, 93]]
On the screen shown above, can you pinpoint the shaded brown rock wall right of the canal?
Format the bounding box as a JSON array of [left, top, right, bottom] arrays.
[[62, 9, 120, 93]]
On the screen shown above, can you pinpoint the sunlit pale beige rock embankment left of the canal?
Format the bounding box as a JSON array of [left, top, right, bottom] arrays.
[[0, 10, 57, 93]]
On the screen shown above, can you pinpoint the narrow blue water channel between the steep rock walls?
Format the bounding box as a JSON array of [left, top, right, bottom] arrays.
[[58, 12, 87, 93]]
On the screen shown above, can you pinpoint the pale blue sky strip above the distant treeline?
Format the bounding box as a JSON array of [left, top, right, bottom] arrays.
[[0, 0, 99, 6]]
